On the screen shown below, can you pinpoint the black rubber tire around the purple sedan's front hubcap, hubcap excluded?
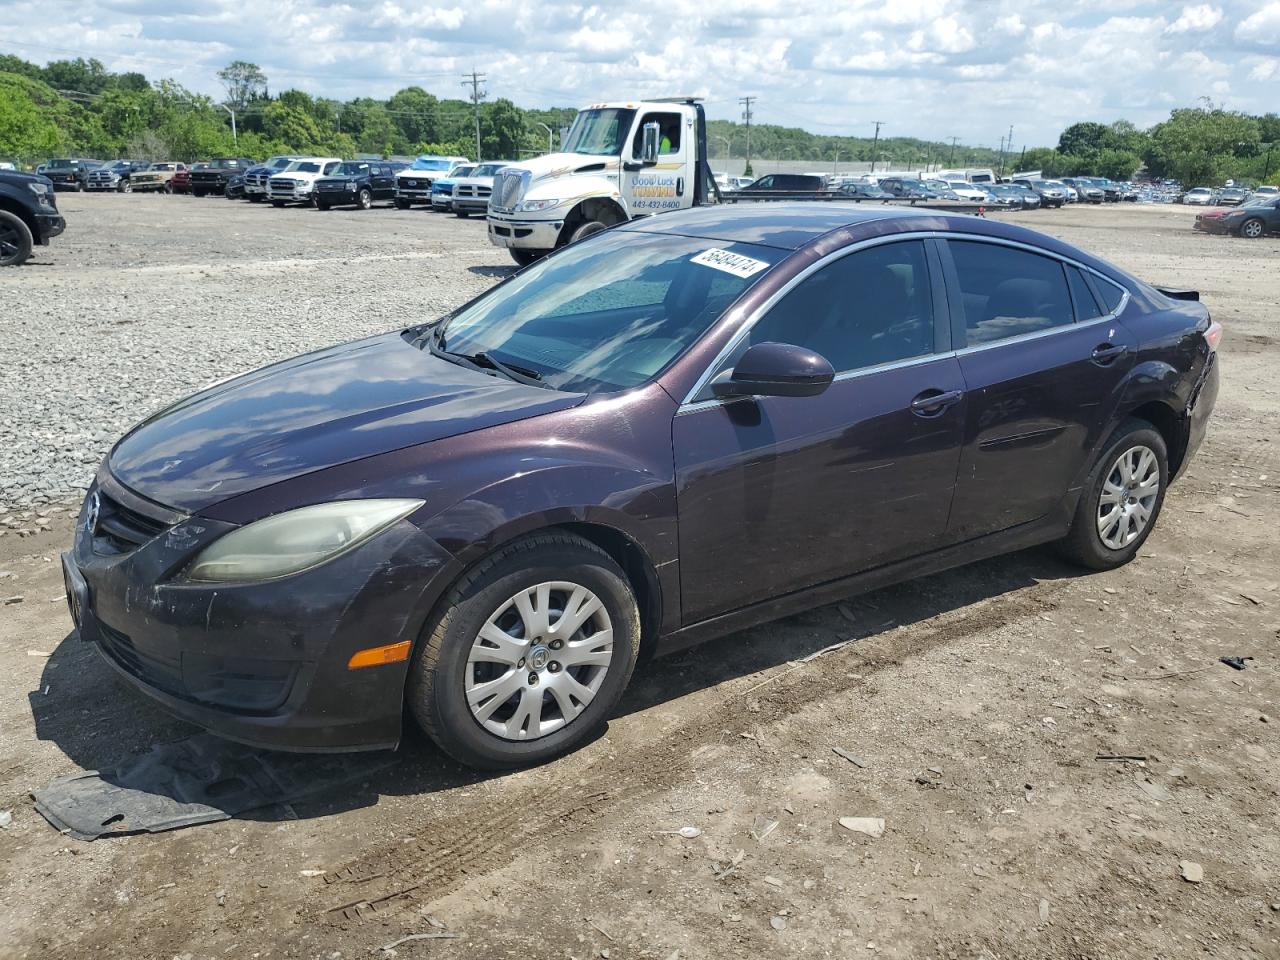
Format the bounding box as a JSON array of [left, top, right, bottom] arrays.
[[406, 532, 640, 769]]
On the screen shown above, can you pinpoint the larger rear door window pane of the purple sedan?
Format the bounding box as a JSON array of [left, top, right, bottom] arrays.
[[947, 241, 1075, 347]]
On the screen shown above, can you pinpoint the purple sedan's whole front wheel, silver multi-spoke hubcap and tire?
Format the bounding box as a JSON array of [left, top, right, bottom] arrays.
[[407, 532, 640, 769]]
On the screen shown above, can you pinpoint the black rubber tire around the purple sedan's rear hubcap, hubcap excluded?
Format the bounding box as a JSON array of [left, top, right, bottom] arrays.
[[1057, 417, 1169, 570]]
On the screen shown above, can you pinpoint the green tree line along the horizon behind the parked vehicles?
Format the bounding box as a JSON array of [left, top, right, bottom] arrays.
[[0, 55, 1280, 186]]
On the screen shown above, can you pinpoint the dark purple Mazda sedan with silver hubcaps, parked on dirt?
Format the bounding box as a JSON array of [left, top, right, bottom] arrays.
[[64, 204, 1221, 768]]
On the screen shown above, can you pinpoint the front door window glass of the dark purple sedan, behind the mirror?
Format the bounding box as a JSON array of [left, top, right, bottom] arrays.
[[735, 241, 934, 374]]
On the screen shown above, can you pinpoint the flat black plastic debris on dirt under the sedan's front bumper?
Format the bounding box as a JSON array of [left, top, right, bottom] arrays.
[[32, 733, 398, 840]]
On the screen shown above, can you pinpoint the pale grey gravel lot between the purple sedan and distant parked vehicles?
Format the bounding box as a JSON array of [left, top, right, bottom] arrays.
[[0, 193, 511, 522]]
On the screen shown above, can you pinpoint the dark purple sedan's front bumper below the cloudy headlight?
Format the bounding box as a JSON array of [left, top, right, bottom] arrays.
[[64, 475, 452, 751]]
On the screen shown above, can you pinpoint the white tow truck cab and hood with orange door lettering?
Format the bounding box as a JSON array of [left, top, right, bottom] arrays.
[[488, 97, 716, 265]]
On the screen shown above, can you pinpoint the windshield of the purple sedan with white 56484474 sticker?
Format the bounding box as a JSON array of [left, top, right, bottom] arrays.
[[434, 230, 787, 393]]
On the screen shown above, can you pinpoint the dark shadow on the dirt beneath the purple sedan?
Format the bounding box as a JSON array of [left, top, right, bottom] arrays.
[[28, 549, 1082, 839]]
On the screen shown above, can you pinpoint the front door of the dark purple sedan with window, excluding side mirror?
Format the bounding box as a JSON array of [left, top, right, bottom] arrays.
[[672, 239, 964, 623]]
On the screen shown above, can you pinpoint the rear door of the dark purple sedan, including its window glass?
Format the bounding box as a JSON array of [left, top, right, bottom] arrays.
[[941, 238, 1137, 540]]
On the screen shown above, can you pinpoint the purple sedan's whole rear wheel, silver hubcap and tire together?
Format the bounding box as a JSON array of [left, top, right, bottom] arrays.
[[1059, 419, 1169, 570]]
